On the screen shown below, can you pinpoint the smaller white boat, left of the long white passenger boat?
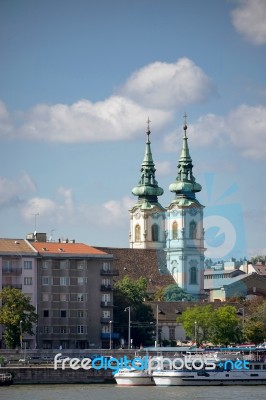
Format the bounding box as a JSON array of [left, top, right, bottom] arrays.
[[114, 368, 154, 386]]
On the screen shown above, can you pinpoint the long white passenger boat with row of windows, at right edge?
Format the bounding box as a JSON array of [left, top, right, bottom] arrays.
[[153, 362, 266, 386]]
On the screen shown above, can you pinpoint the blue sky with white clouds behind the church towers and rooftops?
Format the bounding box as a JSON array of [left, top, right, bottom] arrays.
[[0, 0, 266, 259]]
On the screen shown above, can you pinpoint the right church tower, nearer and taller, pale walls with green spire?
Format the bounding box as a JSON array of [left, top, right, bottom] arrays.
[[165, 114, 205, 296]]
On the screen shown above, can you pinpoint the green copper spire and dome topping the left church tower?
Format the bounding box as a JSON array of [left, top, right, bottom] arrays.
[[132, 119, 163, 203]]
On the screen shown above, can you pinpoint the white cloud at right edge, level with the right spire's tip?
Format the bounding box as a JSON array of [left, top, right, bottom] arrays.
[[164, 104, 266, 159]]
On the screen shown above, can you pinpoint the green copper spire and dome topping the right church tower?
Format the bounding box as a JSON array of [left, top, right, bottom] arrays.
[[169, 115, 202, 199]]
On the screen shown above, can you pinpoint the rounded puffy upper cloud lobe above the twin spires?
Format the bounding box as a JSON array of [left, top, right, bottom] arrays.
[[121, 58, 214, 109]]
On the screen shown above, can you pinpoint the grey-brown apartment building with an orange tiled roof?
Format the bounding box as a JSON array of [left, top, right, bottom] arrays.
[[32, 241, 116, 349]]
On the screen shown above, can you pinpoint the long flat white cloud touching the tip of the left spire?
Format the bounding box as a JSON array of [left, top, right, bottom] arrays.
[[18, 96, 171, 143]]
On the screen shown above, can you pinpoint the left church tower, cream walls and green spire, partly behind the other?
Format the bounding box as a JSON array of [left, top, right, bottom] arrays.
[[129, 119, 165, 249]]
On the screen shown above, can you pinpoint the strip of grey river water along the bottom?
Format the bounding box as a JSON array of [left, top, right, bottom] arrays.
[[0, 384, 266, 400]]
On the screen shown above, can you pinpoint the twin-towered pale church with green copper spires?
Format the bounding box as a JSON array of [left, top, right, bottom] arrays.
[[129, 115, 205, 297]]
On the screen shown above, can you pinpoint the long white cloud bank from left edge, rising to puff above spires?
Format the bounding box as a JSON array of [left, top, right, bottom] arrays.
[[0, 58, 214, 143]]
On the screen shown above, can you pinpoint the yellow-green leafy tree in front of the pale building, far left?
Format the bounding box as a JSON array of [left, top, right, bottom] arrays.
[[0, 287, 37, 348]]
